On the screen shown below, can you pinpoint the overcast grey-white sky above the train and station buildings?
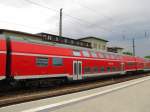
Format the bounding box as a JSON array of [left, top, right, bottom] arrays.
[[0, 0, 150, 56]]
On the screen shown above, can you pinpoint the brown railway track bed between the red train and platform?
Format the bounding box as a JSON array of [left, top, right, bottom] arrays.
[[0, 73, 150, 107]]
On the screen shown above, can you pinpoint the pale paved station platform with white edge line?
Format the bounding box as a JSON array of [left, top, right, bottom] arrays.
[[0, 76, 150, 112]]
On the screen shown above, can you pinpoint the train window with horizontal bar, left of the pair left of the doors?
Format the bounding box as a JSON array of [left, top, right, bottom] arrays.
[[36, 57, 48, 67]]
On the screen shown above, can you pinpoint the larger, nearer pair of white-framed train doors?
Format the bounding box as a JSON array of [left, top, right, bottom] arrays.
[[73, 61, 82, 80]]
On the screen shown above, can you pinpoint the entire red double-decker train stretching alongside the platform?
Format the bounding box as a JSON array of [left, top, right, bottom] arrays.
[[0, 30, 150, 85]]
